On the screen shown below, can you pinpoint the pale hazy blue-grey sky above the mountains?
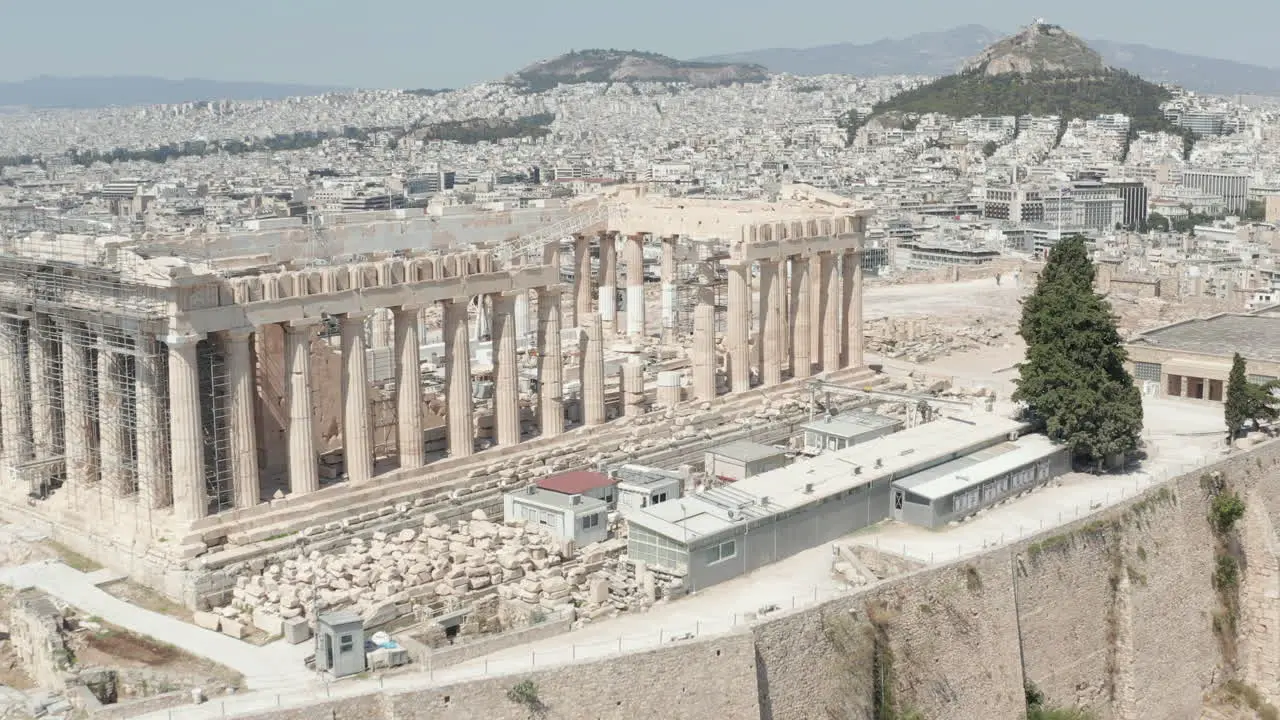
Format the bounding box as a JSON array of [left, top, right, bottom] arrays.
[[0, 0, 1280, 87]]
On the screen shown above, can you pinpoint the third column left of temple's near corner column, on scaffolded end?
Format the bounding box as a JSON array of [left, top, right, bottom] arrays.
[[61, 320, 96, 484]]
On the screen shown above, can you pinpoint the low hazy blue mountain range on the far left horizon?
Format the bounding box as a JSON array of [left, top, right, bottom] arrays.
[[0, 76, 340, 108]]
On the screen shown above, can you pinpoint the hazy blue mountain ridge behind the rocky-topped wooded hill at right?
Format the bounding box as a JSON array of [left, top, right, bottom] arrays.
[[699, 26, 1280, 95]]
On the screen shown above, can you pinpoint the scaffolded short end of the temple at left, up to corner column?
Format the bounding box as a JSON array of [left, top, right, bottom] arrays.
[[0, 245, 192, 507]]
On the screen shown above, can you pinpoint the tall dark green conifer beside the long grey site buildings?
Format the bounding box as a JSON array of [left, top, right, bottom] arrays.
[[1014, 236, 1142, 465]]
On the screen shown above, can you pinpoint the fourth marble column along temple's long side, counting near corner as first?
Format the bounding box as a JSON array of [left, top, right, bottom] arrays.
[[338, 313, 374, 483]]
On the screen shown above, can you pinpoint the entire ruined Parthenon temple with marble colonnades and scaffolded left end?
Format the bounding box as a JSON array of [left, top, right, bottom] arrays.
[[0, 185, 869, 599]]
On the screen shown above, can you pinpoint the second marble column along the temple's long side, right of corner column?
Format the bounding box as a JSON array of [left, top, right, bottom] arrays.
[[226, 328, 262, 507]]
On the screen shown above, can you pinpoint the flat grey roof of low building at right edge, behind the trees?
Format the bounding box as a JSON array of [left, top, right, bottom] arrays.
[[1132, 315, 1280, 363]]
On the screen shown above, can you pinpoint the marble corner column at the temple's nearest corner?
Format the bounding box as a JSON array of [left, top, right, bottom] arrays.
[[165, 336, 209, 523]]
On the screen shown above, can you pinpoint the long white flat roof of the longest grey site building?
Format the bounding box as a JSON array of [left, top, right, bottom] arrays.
[[627, 415, 1023, 543]]
